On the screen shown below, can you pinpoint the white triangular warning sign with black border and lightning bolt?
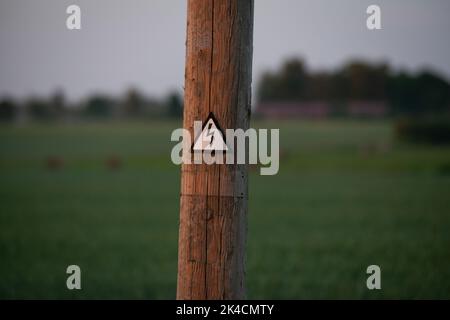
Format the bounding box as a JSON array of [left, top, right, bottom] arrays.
[[192, 113, 228, 151]]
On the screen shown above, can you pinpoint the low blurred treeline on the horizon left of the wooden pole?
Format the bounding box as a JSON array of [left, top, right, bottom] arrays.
[[0, 88, 183, 122]]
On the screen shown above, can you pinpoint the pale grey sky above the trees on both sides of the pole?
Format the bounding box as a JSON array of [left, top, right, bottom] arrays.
[[0, 0, 450, 99]]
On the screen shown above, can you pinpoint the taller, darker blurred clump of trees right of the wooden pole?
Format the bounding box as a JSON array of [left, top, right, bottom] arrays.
[[257, 58, 450, 116]]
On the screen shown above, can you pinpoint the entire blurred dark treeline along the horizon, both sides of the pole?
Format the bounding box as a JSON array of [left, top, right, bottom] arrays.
[[0, 58, 450, 122]]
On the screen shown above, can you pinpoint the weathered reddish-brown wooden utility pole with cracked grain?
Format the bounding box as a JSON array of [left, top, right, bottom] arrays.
[[177, 0, 253, 299]]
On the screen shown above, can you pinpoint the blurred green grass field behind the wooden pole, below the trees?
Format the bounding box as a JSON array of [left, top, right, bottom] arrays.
[[0, 121, 450, 299]]
